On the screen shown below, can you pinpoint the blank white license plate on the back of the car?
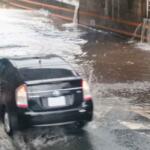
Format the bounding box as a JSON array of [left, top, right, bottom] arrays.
[[48, 96, 66, 107]]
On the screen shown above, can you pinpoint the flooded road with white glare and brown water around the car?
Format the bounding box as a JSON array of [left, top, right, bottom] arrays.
[[0, 3, 150, 150]]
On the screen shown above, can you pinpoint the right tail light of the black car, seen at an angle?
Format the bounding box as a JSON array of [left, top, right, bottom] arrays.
[[82, 80, 92, 101]]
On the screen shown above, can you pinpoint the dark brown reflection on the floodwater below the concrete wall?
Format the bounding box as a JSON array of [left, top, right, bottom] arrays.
[[80, 30, 150, 83]]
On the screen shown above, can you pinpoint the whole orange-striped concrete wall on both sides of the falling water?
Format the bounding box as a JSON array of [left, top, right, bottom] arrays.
[[5, 0, 146, 37]]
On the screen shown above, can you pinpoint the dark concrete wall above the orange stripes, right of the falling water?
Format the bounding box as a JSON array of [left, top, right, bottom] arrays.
[[80, 0, 146, 21]]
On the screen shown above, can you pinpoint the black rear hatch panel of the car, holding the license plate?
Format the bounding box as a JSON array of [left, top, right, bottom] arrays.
[[26, 77, 83, 112]]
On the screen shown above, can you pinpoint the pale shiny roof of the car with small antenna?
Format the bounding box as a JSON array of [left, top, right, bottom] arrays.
[[8, 55, 73, 70]]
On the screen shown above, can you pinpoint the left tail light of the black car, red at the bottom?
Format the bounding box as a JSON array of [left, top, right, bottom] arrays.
[[16, 84, 28, 108]]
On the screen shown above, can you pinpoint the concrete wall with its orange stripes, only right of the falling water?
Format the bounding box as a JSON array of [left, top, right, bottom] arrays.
[[80, 0, 146, 36]]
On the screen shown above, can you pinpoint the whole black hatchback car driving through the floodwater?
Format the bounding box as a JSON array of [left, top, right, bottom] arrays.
[[0, 55, 93, 135]]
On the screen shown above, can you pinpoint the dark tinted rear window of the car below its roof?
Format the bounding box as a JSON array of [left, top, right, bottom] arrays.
[[19, 68, 74, 80]]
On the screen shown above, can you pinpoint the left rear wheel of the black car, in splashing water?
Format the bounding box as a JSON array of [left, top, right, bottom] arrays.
[[3, 110, 18, 136]]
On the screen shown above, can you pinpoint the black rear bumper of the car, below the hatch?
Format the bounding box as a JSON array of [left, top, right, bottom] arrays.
[[19, 103, 93, 126]]
